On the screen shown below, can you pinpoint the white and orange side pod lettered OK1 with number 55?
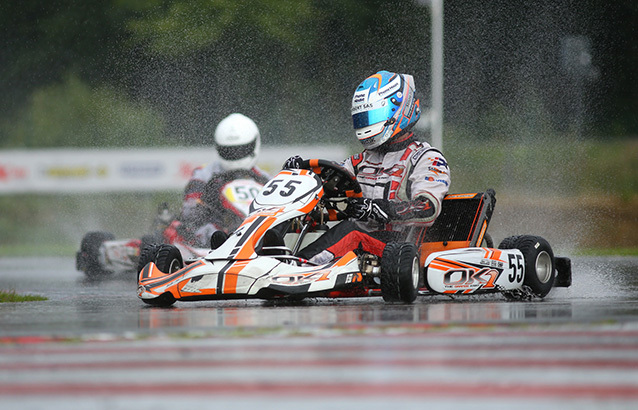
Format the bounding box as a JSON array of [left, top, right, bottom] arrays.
[[424, 248, 528, 294]]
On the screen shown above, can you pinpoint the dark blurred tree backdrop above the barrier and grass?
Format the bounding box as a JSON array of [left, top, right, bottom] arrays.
[[0, 0, 638, 148]]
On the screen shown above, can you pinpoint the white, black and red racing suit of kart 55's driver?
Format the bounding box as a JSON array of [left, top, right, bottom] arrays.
[[298, 133, 450, 264]]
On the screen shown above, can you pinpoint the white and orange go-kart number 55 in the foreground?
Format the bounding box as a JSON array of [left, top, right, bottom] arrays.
[[138, 159, 571, 306]]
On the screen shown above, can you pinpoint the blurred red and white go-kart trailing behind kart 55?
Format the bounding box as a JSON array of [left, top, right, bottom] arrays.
[[75, 177, 263, 277]]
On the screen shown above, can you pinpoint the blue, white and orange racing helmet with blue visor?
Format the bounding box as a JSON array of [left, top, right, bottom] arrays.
[[352, 71, 421, 149]]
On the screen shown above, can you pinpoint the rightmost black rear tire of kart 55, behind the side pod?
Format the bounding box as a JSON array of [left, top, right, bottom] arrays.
[[498, 235, 556, 298]]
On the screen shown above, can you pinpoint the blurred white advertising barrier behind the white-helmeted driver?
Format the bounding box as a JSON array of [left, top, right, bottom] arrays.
[[0, 145, 348, 195]]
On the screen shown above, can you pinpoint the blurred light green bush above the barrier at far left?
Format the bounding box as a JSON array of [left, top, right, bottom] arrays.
[[7, 76, 165, 148]]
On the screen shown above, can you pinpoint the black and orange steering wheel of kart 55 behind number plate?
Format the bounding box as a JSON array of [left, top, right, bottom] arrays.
[[299, 159, 362, 198]]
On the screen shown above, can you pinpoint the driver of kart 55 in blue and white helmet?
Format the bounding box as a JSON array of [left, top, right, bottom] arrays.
[[284, 71, 450, 264]]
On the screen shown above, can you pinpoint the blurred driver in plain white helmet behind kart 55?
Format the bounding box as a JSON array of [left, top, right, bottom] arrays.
[[164, 113, 269, 247]]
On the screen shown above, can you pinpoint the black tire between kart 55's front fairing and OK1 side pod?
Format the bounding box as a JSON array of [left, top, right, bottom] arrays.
[[381, 242, 421, 303]]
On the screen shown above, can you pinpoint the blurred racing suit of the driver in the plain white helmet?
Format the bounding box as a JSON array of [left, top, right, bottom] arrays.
[[164, 163, 269, 247]]
